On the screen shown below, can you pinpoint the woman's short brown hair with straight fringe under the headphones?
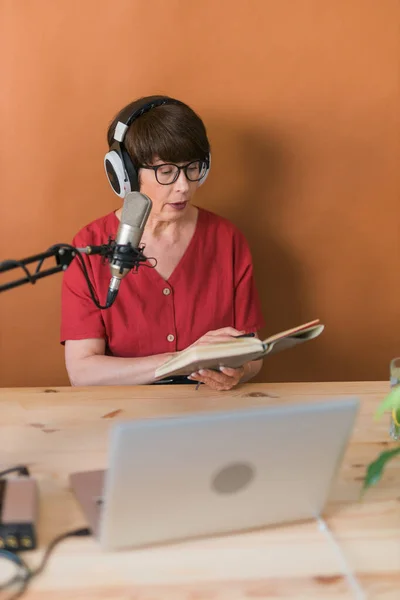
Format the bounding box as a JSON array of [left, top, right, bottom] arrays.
[[107, 96, 210, 169]]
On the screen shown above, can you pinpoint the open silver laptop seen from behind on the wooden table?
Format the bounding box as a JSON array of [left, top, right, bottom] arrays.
[[70, 398, 359, 549]]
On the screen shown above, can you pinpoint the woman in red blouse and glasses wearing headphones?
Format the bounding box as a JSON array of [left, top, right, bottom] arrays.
[[61, 96, 264, 390]]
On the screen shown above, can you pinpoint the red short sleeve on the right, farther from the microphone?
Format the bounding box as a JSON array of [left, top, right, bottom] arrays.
[[234, 231, 265, 333]]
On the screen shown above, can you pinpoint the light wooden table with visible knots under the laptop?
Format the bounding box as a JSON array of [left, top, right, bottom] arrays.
[[0, 382, 400, 600]]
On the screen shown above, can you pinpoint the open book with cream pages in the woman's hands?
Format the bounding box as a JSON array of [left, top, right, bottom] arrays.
[[155, 319, 324, 379]]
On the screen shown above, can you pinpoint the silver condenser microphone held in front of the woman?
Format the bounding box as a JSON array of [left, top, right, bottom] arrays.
[[106, 192, 152, 307]]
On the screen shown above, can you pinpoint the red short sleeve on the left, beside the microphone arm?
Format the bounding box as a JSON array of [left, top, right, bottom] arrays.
[[60, 238, 106, 343]]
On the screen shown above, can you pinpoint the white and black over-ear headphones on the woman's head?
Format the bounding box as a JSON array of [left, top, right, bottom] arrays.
[[104, 97, 211, 198]]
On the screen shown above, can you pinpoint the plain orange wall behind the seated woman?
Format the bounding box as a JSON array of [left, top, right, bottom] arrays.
[[0, 0, 400, 386]]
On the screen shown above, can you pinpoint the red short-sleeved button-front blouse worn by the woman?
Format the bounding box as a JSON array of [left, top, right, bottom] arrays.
[[61, 209, 264, 357]]
